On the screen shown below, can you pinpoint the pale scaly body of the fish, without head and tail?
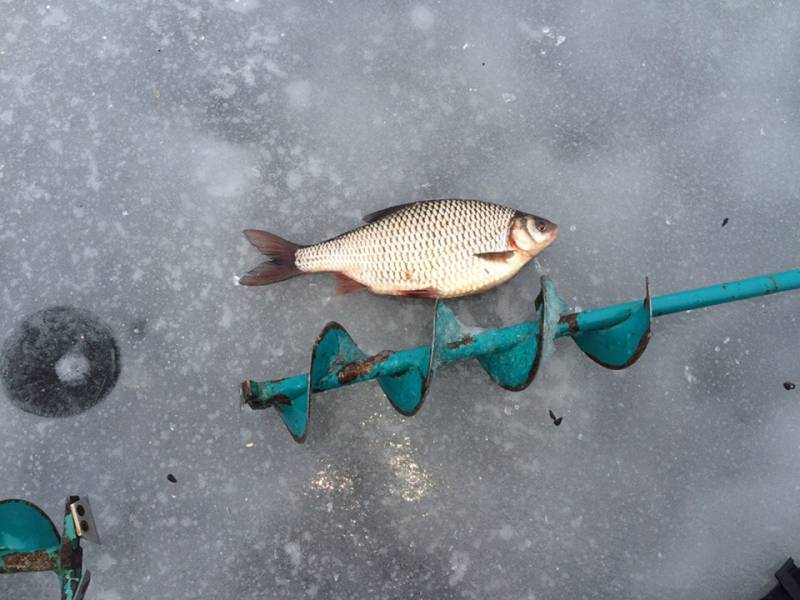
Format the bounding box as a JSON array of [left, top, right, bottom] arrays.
[[295, 200, 516, 296]]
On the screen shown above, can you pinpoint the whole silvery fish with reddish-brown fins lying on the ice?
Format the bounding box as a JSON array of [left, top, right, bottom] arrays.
[[239, 199, 558, 298]]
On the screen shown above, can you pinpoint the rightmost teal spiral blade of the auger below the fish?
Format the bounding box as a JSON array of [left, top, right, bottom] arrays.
[[573, 280, 653, 369]]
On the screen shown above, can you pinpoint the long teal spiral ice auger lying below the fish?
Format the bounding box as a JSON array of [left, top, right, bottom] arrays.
[[242, 269, 800, 442]]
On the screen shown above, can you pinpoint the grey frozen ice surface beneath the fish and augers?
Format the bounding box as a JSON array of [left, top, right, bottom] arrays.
[[0, 0, 800, 600]]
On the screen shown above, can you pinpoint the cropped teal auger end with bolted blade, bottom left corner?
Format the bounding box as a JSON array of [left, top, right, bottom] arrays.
[[0, 496, 100, 600]]
